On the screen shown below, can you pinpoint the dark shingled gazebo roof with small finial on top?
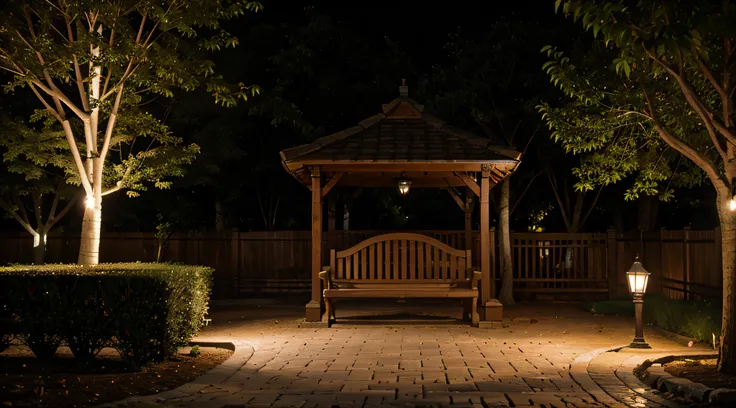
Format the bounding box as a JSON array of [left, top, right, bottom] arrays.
[[281, 86, 521, 188]]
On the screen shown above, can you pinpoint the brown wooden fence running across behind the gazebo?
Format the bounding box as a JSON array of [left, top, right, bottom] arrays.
[[0, 229, 722, 300]]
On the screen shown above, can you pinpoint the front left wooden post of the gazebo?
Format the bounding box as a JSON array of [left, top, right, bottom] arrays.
[[305, 166, 322, 322]]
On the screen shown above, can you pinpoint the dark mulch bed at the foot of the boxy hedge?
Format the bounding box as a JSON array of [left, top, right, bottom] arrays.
[[0, 345, 232, 407]]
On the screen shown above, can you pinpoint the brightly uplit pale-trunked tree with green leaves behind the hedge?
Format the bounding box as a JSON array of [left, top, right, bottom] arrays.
[[0, 0, 261, 264]]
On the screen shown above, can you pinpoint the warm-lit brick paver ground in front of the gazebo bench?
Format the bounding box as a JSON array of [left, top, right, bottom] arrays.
[[141, 303, 712, 408]]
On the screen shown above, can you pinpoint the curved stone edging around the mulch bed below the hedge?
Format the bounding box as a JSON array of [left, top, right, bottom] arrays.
[[97, 341, 255, 408]]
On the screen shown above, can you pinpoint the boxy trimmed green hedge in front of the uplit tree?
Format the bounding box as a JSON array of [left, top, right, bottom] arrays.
[[0, 263, 213, 366]]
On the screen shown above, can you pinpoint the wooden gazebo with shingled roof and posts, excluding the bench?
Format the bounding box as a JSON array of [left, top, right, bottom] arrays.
[[281, 85, 520, 322]]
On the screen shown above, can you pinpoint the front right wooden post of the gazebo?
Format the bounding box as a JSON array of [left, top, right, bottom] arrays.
[[480, 165, 493, 320]]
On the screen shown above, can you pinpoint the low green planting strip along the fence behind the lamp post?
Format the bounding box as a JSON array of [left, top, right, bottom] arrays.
[[584, 295, 721, 343]]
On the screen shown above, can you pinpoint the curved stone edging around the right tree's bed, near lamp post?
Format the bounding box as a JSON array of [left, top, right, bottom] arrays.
[[628, 354, 736, 406]]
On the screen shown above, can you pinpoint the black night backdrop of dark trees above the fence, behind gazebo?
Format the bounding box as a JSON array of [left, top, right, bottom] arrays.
[[0, 1, 716, 231]]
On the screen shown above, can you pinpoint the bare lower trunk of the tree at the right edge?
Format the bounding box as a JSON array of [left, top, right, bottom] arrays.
[[718, 195, 736, 373]]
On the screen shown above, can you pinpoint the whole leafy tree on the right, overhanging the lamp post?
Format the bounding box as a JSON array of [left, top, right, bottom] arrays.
[[540, 0, 736, 372]]
